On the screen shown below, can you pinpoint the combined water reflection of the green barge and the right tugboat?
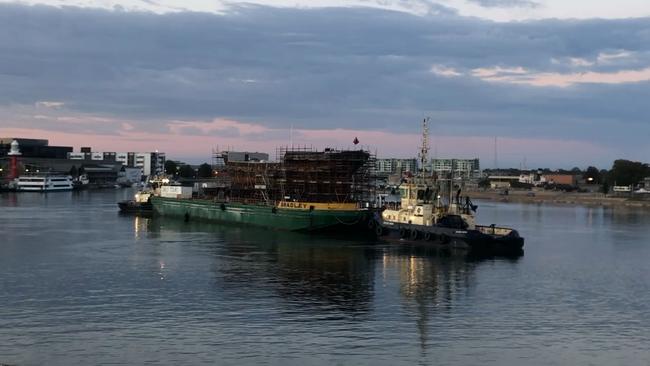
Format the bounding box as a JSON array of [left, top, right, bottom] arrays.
[[135, 214, 518, 338]]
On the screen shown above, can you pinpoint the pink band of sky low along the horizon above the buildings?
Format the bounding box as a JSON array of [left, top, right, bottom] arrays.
[[0, 120, 616, 168]]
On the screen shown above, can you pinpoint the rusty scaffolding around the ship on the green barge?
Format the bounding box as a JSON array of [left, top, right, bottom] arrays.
[[210, 146, 376, 205]]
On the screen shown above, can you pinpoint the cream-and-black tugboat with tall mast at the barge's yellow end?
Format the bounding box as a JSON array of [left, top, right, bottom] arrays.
[[371, 119, 524, 255]]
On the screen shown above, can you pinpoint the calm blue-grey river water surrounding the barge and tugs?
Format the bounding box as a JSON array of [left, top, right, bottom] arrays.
[[0, 190, 650, 365]]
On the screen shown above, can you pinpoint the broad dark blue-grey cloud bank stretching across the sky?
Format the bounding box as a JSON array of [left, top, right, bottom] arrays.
[[0, 0, 650, 160]]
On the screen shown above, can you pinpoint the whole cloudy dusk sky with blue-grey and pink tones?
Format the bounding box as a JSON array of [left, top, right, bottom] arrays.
[[0, 0, 650, 168]]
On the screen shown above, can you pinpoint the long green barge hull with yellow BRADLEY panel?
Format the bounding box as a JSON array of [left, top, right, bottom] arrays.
[[151, 196, 371, 231]]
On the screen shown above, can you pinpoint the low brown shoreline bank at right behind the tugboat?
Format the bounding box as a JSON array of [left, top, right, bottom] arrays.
[[466, 190, 650, 209]]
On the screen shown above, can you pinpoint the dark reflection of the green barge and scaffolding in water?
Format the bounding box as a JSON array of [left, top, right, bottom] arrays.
[[138, 218, 377, 314]]
